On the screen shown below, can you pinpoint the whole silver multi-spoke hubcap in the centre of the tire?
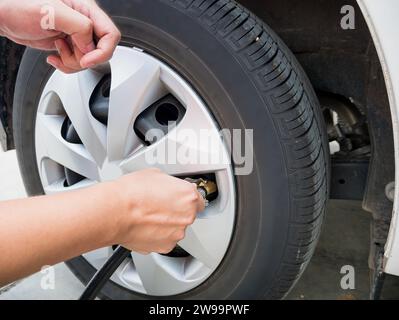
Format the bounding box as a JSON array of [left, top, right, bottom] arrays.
[[36, 47, 235, 296]]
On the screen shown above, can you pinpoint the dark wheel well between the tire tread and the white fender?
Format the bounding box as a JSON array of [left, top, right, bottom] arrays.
[[239, 0, 395, 270]]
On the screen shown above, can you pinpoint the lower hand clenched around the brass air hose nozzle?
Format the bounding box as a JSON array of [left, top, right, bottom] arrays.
[[111, 169, 205, 254]]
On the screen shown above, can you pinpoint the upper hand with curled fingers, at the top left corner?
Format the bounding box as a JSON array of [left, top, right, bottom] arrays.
[[0, 0, 121, 73]]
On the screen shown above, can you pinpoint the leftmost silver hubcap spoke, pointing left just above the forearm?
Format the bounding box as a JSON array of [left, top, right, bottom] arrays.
[[37, 114, 99, 181]]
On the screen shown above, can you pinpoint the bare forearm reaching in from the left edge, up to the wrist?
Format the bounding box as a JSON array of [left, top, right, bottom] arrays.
[[0, 181, 120, 287]]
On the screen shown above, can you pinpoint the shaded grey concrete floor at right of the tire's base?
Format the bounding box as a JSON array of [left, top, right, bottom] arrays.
[[289, 201, 399, 300]]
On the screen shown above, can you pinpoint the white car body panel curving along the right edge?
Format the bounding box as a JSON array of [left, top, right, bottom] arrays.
[[358, 0, 399, 275]]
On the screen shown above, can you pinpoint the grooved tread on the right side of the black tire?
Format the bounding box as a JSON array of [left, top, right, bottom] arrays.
[[171, 0, 329, 299]]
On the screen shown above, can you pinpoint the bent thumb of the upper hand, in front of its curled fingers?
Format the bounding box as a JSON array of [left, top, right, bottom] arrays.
[[55, 2, 96, 54]]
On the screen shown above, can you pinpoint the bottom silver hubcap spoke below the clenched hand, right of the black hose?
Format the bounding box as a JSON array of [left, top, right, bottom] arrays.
[[132, 253, 202, 296]]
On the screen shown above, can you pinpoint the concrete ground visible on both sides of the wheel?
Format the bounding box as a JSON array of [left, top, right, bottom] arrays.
[[0, 151, 399, 300]]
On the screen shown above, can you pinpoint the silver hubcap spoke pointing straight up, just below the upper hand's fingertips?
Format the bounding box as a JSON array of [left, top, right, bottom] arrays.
[[108, 49, 166, 161]]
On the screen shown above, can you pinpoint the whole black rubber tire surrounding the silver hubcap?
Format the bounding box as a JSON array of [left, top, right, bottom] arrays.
[[14, 0, 329, 299]]
